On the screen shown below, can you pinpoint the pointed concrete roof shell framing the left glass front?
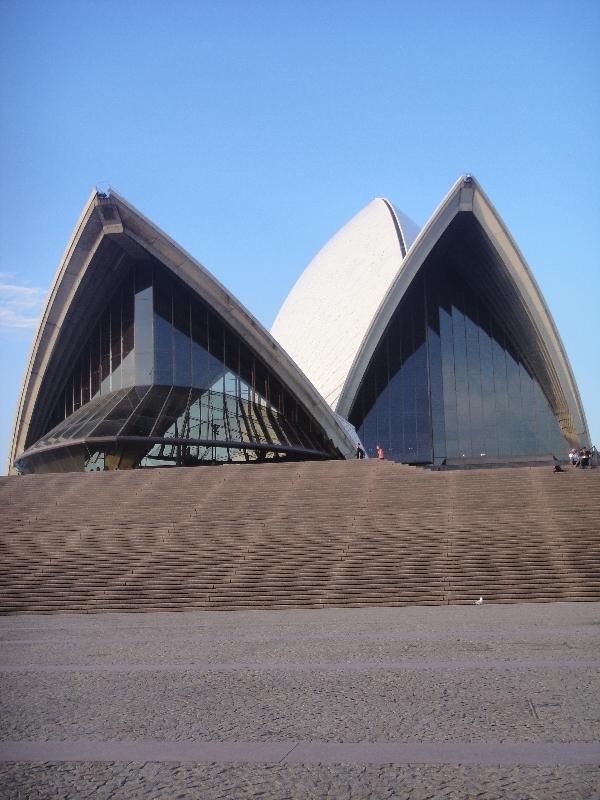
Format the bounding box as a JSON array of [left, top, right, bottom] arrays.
[[9, 191, 355, 470]]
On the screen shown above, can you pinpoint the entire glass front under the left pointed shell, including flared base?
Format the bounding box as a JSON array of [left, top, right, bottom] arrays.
[[27, 253, 339, 472]]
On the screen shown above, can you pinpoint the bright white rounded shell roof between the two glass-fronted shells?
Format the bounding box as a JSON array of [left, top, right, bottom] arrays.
[[271, 198, 419, 408]]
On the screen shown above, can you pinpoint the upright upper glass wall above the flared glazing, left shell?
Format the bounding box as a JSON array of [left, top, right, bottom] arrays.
[[46, 263, 326, 440]]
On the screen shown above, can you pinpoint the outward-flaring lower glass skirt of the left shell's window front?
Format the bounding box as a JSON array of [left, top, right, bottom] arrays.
[[16, 386, 334, 472]]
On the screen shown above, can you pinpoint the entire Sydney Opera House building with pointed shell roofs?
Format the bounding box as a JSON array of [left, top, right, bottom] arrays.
[[10, 176, 589, 473]]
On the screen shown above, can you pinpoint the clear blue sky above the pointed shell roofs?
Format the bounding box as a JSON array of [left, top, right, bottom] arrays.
[[0, 0, 600, 467]]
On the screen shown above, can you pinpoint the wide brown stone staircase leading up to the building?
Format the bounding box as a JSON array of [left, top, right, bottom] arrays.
[[0, 460, 600, 613]]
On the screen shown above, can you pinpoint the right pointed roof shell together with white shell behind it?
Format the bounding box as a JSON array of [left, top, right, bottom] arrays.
[[272, 176, 589, 444]]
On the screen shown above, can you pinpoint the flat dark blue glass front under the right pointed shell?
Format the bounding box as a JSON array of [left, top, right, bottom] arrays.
[[350, 216, 570, 463]]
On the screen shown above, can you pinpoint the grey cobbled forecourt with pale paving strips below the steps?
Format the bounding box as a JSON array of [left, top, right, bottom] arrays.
[[0, 603, 600, 800]]
